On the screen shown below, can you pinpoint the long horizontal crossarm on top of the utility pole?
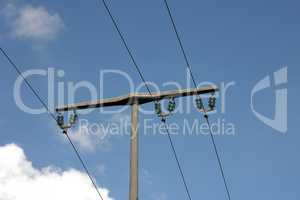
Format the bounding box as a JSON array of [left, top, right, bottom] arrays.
[[56, 86, 219, 112]]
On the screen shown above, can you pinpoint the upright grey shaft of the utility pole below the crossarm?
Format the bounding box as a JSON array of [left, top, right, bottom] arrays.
[[129, 102, 139, 200]]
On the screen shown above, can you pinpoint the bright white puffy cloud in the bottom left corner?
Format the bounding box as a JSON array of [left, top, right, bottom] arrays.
[[0, 144, 113, 200]]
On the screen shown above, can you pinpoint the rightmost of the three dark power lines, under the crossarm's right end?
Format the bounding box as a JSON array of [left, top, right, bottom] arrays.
[[164, 0, 231, 200]]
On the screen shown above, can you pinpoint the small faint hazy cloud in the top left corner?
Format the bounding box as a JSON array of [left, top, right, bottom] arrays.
[[2, 3, 64, 41]]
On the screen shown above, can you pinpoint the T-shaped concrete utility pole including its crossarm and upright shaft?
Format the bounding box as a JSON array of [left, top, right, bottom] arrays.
[[56, 87, 218, 200]]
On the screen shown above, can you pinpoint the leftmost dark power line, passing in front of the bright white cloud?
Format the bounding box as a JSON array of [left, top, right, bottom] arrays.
[[0, 47, 104, 200]]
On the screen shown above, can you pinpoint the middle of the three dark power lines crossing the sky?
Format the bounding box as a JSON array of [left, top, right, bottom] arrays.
[[99, 0, 192, 200]]
